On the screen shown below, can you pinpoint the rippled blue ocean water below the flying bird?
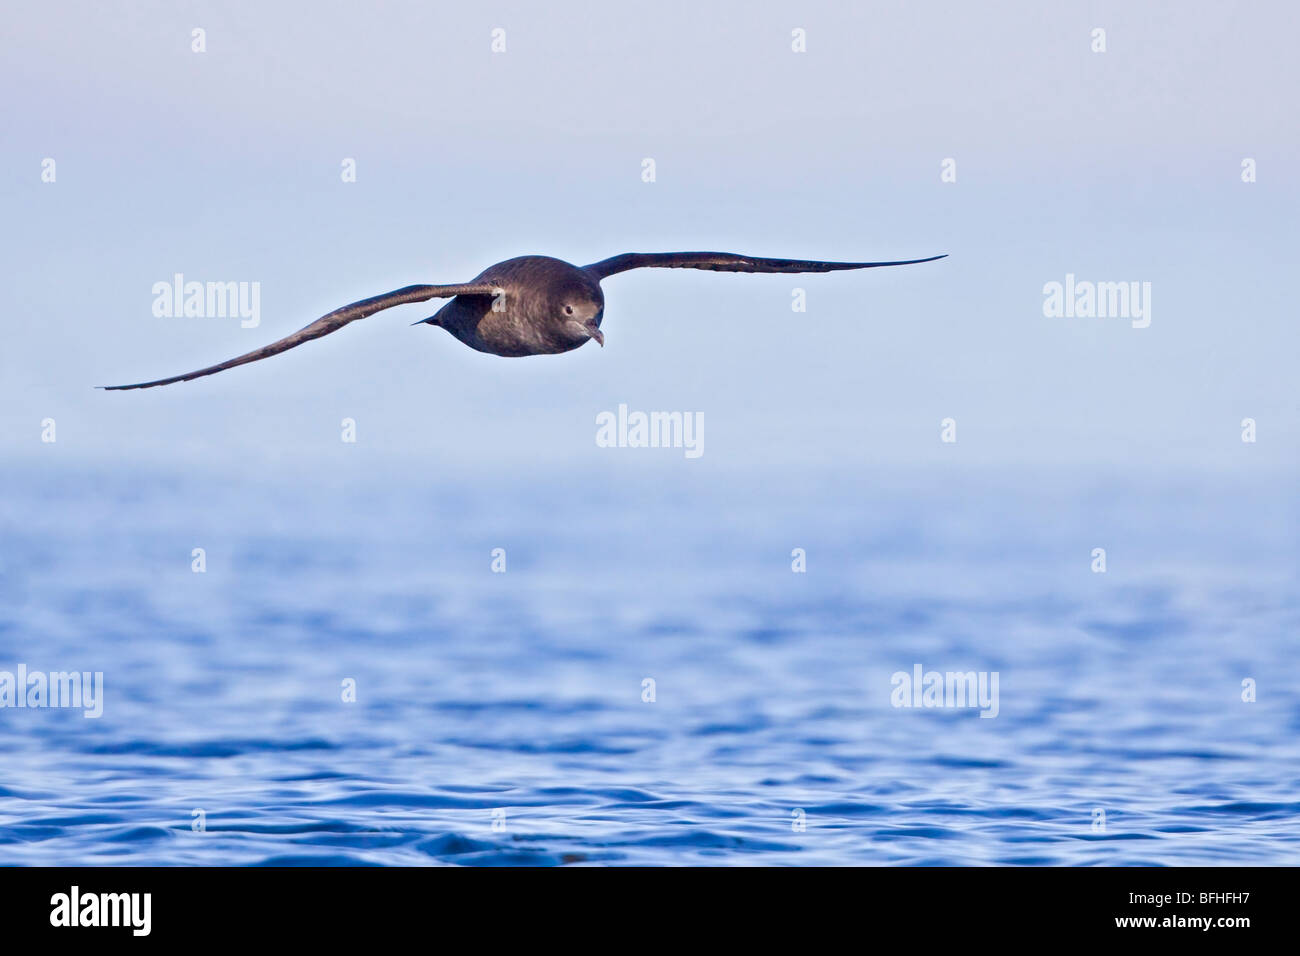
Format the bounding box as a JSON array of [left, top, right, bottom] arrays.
[[0, 463, 1300, 865]]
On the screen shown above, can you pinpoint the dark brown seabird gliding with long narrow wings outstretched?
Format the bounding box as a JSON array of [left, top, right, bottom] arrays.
[[101, 252, 946, 392]]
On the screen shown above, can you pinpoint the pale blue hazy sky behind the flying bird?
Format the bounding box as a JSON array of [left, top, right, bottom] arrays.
[[0, 3, 1300, 475]]
